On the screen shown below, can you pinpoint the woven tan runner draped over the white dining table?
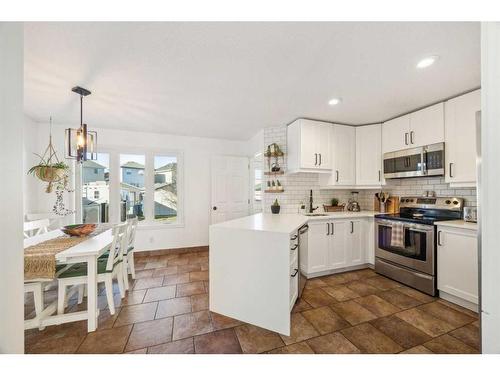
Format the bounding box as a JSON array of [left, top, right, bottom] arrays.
[[24, 225, 112, 280]]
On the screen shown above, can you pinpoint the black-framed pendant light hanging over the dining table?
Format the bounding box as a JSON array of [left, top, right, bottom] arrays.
[[65, 86, 97, 163]]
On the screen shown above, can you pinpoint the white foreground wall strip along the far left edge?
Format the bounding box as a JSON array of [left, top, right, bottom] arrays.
[[0, 23, 24, 353]]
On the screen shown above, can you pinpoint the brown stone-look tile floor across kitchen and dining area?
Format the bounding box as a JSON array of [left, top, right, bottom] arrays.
[[25, 251, 479, 354]]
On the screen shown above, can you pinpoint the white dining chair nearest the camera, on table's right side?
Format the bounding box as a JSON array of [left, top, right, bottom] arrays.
[[57, 223, 128, 315]]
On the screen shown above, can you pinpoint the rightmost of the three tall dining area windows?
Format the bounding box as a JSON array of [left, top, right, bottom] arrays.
[[154, 155, 178, 222]]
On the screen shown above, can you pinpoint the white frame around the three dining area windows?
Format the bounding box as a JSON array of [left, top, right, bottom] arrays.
[[75, 146, 185, 229]]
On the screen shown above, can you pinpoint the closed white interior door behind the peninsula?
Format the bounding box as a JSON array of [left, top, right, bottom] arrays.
[[211, 156, 249, 224]]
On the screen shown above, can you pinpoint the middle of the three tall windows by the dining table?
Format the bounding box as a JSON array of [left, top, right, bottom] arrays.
[[120, 154, 146, 221]]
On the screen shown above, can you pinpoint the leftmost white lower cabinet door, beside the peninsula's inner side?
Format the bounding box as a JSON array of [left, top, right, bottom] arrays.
[[307, 222, 330, 273]]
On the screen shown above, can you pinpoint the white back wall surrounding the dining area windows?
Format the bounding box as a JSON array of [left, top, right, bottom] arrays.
[[24, 123, 250, 250]]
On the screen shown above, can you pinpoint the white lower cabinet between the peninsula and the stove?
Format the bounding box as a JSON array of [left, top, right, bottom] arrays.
[[301, 219, 370, 276]]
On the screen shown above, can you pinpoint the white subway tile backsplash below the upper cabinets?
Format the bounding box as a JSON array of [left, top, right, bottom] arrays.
[[263, 126, 476, 213]]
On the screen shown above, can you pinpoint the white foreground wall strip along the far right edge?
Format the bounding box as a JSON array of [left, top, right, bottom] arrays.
[[479, 22, 500, 353]]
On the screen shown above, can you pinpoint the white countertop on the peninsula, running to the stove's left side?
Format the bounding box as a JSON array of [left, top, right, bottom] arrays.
[[211, 211, 375, 233]]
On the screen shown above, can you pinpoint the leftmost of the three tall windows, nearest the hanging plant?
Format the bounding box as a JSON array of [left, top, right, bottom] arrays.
[[81, 153, 109, 223]]
